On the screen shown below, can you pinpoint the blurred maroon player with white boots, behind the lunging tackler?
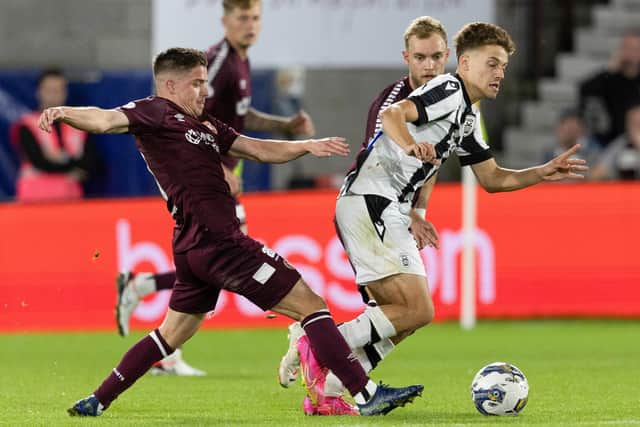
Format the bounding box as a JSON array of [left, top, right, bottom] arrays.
[[116, 0, 315, 375]]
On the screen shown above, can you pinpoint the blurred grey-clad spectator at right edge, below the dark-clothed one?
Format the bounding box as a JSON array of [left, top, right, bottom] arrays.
[[591, 103, 640, 180]]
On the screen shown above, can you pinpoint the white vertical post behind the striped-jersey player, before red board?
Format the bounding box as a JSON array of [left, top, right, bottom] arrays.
[[460, 166, 478, 329]]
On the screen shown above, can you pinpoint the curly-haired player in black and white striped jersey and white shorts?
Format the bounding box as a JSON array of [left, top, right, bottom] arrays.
[[280, 19, 588, 414]]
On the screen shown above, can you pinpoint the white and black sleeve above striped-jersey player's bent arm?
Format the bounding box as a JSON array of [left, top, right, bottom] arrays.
[[408, 80, 463, 126]]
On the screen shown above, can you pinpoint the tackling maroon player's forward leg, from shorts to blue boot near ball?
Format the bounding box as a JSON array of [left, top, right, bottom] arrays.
[[208, 231, 422, 415]]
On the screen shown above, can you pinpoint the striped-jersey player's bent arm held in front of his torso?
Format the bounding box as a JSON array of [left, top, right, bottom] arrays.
[[380, 99, 440, 164]]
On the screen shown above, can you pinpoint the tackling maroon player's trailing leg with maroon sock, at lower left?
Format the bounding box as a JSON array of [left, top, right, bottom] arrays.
[[67, 309, 204, 416]]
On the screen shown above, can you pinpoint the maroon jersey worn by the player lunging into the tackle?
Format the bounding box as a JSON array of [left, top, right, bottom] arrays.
[[120, 96, 239, 253]]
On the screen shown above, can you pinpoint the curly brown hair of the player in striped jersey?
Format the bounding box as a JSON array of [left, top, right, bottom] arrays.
[[453, 22, 516, 58]]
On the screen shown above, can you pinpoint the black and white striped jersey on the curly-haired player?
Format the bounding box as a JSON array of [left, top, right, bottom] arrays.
[[340, 74, 492, 203]]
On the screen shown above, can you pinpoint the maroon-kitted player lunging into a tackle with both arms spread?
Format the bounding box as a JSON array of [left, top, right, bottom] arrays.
[[39, 48, 423, 416]]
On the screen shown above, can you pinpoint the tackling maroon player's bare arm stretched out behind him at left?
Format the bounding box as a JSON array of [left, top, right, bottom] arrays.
[[38, 107, 129, 133]]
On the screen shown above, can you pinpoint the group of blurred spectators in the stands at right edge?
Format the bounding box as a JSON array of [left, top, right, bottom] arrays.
[[543, 31, 640, 180]]
